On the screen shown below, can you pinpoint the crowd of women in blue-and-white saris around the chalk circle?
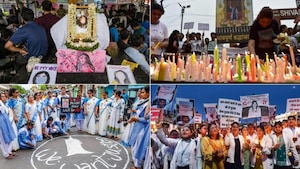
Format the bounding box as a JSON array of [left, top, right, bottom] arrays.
[[0, 86, 150, 168]]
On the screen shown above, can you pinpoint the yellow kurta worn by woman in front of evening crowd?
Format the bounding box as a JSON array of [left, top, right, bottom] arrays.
[[201, 136, 227, 169]]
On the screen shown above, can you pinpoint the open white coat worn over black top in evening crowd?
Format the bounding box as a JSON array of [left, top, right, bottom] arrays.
[[224, 133, 244, 165]]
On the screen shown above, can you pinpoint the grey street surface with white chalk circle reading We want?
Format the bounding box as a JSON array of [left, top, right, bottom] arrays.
[[0, 127, 132, 169]]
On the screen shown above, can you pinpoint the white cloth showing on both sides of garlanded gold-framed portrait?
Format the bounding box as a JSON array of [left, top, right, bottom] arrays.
[[50, 14, 110, 50]]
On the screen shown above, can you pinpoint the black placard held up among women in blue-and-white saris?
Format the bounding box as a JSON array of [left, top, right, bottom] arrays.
[[61, 97, 81, 113]]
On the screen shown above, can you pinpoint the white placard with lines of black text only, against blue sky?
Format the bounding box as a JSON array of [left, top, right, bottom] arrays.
[[218, 99, 243, 117]]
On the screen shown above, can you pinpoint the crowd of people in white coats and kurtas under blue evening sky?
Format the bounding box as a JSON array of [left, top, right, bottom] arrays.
[[151, 115, 300, 169]]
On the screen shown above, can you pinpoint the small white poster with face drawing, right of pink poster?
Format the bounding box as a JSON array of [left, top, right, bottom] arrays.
[[106, 65, 136, 84]]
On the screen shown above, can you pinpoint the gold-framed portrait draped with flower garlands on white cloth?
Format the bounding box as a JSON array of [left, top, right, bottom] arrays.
[[66, 3, 99, 51]]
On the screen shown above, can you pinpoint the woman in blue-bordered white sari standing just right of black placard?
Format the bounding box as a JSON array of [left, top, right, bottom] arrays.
[[83, 89, 99, 135]]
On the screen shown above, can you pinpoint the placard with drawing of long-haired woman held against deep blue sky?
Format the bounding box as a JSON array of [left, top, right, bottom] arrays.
[[240, 94, 269, 118]]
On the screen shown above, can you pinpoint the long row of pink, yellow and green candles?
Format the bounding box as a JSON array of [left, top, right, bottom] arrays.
[[150, 46, 300, 83]]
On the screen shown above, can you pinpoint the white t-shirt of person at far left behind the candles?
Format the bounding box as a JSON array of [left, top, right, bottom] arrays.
[[150, 21, 169, 55]]
